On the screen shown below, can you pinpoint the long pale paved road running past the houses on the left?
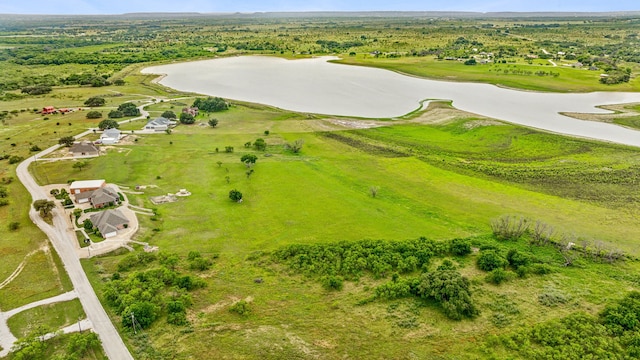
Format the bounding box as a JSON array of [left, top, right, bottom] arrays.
[[16, 141, 133, 360]]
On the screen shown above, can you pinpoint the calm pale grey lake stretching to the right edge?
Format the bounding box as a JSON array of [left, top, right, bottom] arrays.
[[142, 56, 640, 146]]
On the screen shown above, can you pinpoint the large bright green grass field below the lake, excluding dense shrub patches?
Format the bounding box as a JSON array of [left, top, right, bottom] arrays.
[[27, 95, 638, 358]]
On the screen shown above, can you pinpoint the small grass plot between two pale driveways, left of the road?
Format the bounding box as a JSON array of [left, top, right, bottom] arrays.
[[7, 299, 86, 338]]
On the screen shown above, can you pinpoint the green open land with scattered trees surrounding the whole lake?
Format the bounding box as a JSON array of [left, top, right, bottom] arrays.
[[0, 11, 640, 359]]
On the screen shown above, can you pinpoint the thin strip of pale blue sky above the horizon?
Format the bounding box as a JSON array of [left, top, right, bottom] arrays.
[[0, 0, 640, 15]]
